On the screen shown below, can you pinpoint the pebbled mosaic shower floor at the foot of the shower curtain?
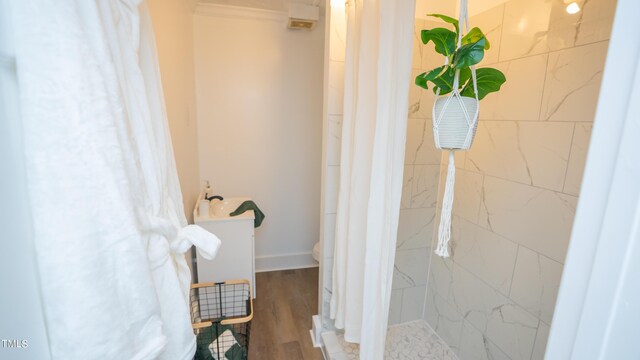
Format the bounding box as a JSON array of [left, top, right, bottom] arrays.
[[323, 321, 458, 360]]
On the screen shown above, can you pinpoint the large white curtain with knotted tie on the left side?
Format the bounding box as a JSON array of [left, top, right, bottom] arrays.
[[11, 0, 220, 360]]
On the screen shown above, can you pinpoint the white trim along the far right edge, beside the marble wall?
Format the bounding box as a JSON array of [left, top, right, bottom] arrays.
[[545, 0, 640, 360]]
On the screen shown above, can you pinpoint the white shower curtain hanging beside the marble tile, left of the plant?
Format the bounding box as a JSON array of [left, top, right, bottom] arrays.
[[331, 0, 415, 360]]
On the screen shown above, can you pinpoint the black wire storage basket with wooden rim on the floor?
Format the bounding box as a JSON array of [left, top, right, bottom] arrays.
[[190, 280, 253, 360]]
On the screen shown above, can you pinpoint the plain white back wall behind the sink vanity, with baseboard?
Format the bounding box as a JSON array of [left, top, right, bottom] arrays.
[[194, 5, 324, 271]]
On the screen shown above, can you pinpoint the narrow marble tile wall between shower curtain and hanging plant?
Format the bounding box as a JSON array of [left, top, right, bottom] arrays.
[[389, 18, 441, 325]]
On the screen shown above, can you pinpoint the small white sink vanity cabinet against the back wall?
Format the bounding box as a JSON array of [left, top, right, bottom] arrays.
[[193, 197, 256, 298]]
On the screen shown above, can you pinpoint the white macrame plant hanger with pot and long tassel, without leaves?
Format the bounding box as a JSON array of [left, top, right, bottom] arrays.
[[432, 0, 480, 258]]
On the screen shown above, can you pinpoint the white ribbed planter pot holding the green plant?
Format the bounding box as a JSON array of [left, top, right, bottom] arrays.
[[433, 95, 478, 150]]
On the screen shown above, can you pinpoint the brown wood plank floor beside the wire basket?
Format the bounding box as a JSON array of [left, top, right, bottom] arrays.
[[249, 268, 322, 360]]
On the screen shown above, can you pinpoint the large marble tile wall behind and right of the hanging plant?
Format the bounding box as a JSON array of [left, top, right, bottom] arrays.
[[422, 0, 615, 360]]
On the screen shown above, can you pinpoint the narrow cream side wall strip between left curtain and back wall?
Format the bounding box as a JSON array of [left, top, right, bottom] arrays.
[[147, 0, 200, 222]]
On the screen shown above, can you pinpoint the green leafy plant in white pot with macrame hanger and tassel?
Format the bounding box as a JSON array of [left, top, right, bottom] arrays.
[[416, 11, 506, 257]]
